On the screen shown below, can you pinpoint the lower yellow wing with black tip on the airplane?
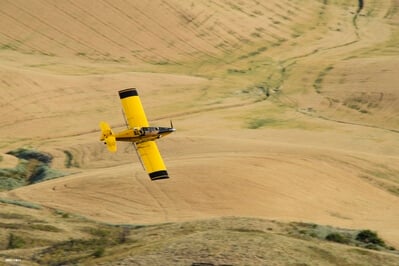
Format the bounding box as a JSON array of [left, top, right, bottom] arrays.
[[136, 141, 169, 180]]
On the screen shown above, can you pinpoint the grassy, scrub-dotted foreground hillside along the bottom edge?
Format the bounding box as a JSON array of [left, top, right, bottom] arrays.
[[0, 206, 398, 265]]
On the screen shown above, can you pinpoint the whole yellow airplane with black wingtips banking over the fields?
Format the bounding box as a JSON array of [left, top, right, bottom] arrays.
[[100, 89, 175, 180]]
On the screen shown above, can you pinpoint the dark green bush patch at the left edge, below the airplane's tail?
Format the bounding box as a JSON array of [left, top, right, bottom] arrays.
[[0, 148, 65, 191]]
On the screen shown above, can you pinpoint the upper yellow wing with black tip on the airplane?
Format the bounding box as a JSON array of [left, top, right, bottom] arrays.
[[119, 89, 148, 128]]
